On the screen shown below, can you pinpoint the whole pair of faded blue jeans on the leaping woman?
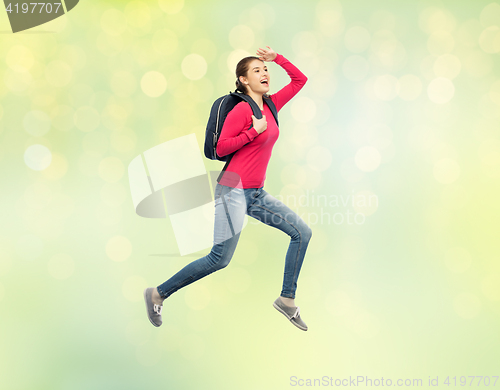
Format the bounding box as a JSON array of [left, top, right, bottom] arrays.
[[157, 183, 312, 298]]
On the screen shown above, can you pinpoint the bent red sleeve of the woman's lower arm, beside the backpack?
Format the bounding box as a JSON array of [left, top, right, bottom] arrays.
[[217, 102, 259, 157]]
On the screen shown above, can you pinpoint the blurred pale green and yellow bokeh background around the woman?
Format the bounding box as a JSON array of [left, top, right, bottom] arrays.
[[0, 0, 500, 390]]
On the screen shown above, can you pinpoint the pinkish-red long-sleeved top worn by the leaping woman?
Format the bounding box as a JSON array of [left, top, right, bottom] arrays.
[[217, 54, 307, 188]]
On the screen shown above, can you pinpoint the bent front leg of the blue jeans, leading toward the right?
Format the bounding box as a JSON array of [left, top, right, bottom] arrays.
[[247, 189, 312, 298]]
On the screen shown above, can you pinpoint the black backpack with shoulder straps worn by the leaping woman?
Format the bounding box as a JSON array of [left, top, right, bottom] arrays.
[[205, 90, 278, 182]]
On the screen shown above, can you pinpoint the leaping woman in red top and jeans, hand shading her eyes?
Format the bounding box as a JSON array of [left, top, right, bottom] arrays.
[[144, 46, 312, 330]]
